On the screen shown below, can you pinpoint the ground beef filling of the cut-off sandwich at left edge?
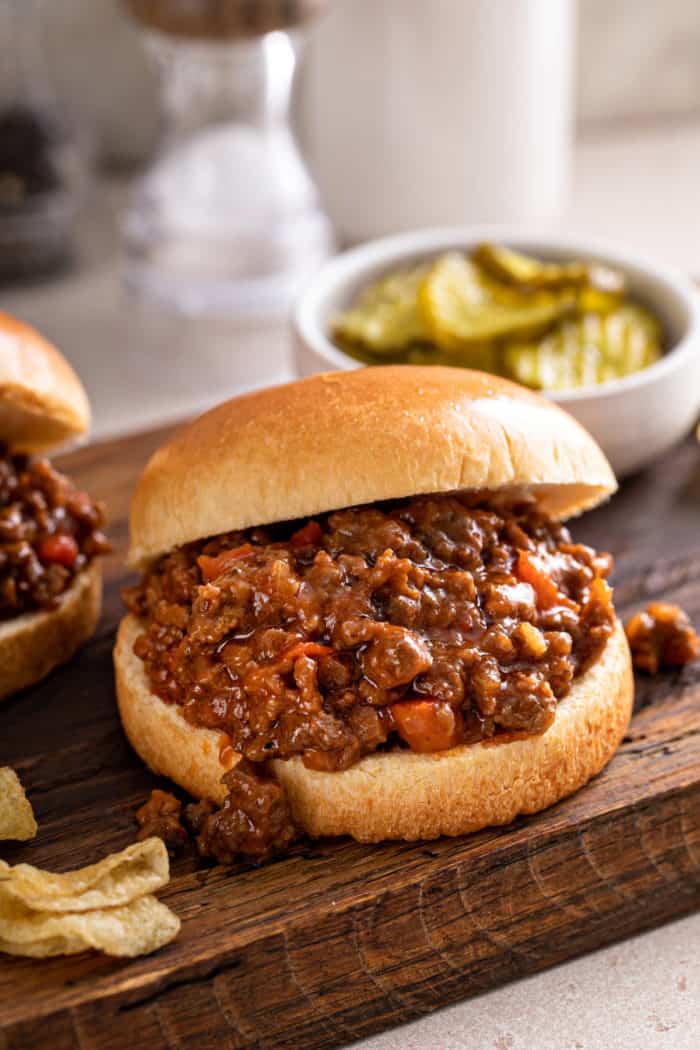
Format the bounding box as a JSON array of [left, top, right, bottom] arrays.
[[0, 445, 109, 620]]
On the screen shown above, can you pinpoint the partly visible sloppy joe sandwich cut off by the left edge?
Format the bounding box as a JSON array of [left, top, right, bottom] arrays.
[[0, 313, 108, 700]]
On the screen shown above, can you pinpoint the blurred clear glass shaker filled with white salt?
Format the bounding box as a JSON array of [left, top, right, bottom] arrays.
[[123, 0, 332, 318]]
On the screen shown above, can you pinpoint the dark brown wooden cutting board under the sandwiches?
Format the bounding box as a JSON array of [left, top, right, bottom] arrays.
[[0, 422, 700, 1050]]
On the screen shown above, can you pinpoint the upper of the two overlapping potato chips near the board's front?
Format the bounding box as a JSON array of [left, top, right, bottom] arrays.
[[0, 838, 170, 914]]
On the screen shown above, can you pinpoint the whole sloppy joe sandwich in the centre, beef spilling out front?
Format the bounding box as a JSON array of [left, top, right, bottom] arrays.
[[114, 366, 633, 859]]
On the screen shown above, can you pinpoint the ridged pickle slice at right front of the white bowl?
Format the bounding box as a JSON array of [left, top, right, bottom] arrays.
[[503, 303, 661, 391]]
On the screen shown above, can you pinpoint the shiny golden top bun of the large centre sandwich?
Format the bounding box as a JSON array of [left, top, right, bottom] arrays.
[[129, 365, 617, 567]]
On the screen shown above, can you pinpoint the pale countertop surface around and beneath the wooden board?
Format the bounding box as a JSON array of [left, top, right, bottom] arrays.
[[0, 120, 700, 1050]]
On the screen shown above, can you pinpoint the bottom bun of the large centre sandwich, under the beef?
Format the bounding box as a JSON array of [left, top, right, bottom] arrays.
[[114, 616, 634, 842]]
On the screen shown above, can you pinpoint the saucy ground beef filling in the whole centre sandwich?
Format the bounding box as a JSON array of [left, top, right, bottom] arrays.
[[125, 496, 614, 860]]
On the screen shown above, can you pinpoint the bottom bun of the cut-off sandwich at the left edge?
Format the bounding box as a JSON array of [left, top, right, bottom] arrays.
[[0, 562, 102, 700]]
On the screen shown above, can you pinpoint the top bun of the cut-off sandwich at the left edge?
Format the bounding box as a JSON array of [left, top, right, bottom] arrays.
[[0, 313, 90, 452]]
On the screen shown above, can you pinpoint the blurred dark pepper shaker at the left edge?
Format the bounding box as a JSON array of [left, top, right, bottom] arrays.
[[0, 0, 85, 281]]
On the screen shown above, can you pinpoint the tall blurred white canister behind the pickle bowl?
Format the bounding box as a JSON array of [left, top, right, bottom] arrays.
[[298, 0, 576, 242]]
